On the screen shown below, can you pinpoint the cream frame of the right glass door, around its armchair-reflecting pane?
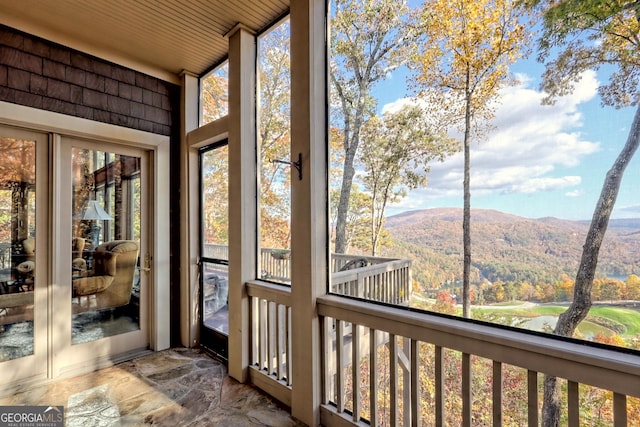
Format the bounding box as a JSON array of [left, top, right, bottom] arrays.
[[50, 134, 154, 377]]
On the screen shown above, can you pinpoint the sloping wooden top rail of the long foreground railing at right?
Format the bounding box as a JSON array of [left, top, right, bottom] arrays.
[[317, 295, 640, 397]]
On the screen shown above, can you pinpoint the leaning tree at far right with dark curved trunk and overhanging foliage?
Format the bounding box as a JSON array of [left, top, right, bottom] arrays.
[[528, 0, 640, 426]]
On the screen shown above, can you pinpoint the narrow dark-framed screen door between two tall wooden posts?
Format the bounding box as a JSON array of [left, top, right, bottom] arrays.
[[199, 141, 229, 360]]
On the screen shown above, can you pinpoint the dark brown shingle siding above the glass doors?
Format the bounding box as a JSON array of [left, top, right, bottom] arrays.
[[0, 26, 179, 135]]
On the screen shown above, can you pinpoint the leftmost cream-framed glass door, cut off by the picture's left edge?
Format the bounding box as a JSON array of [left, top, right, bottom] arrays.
[[0, 127, 48, 385]]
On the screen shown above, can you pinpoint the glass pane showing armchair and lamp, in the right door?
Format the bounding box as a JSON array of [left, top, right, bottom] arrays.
[[70, 147, 141, 344]]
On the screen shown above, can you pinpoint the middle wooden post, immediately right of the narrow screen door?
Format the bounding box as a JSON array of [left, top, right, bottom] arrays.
[[228, 25, 257, 382]]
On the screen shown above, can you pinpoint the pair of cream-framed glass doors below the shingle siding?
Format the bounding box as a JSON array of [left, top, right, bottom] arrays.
[[0, 130, 153, 387]]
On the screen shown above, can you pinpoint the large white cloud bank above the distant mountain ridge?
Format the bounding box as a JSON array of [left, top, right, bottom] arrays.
[[383, 72, 600, 208]]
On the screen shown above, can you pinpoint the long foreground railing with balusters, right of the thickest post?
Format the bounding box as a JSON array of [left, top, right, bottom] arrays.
[[318, 296, 640, 427]]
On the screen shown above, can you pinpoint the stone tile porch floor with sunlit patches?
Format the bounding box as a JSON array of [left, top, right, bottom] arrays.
[[0, 348, 304, 427]]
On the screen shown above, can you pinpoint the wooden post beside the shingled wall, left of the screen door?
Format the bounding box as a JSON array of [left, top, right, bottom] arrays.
[[180, 71, 200, 347]]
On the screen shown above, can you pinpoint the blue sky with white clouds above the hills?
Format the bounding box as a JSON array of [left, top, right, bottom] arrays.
[[374, 59, 640, 220]]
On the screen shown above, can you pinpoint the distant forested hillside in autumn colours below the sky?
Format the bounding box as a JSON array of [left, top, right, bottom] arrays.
[[385, 208, 640, 288]]
